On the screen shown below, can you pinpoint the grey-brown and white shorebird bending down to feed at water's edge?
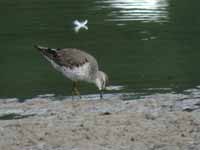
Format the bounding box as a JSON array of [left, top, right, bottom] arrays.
[[35, 45, 108, 99]]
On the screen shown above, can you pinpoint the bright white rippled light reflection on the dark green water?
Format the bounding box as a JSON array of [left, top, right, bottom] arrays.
[[96, 0, 169, 22]]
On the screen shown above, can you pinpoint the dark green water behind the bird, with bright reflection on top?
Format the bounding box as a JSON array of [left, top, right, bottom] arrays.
[[0, 0, 200, 98]]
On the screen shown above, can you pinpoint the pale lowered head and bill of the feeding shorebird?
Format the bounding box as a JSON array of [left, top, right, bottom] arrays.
[[95, 71, 108, 98]]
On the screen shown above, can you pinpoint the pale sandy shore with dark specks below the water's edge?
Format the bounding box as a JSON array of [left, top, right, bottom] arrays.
[[0, 96, 200, 150]]
